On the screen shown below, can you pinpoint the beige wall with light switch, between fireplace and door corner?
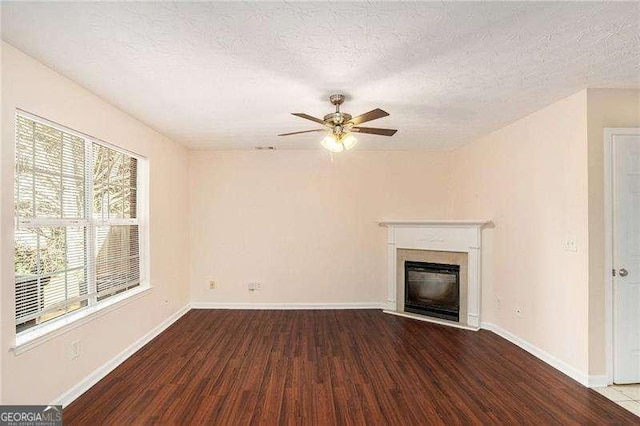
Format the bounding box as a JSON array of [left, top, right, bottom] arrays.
[[453, 91, 588, 373]]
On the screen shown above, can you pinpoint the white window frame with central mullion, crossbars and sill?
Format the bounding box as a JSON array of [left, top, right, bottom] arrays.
[[12, 108, 152, 355]]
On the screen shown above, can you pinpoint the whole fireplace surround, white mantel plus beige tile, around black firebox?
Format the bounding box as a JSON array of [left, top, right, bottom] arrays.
[[379, 220, 489, 330]]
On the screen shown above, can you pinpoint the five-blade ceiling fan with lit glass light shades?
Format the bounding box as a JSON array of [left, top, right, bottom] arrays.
[[278, 93, 397, 152]]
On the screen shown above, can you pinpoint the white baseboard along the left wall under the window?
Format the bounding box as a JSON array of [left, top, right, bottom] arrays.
[[51, 305, 190, 407]]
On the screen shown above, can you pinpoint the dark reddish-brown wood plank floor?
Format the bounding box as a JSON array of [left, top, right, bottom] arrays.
[[64, 310, 640, 425]]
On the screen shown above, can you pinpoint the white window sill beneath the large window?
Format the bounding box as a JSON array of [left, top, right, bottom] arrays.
[[11, 286, 152, 356]]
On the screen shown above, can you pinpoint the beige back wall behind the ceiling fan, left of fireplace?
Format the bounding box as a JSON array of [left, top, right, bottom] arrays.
[[189, 150, 451, 303]]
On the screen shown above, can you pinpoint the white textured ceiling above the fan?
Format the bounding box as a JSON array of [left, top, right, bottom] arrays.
[[1, 2, 640, 149]]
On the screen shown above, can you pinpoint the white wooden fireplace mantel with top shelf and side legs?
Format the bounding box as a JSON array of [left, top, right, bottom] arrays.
[[378, 220, 490, 329]]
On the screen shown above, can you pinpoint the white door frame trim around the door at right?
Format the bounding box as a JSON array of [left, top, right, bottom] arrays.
[[604, 127, 640, 385]]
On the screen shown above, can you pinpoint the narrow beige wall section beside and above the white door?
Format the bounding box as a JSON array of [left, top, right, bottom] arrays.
[[587, 89, 640, 375]]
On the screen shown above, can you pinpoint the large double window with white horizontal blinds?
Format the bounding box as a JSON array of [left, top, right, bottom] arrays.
[[15, 112, 144, 333]]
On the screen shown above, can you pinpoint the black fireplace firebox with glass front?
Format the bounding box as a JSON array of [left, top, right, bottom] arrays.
[[404, 261, 460, 321]]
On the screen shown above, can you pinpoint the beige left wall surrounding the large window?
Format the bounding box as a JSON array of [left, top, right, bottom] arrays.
[[0, 43, 189, 404]]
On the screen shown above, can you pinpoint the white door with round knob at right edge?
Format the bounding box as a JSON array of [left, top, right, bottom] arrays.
[[611, 132, 640, 383]]
